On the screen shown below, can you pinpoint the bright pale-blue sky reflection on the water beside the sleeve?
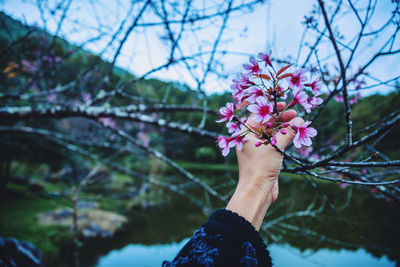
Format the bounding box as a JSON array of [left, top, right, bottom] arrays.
[[97, 238, 396, 267]]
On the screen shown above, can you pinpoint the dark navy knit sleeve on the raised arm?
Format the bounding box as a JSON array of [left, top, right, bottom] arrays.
[[162, 209, 272, 267]]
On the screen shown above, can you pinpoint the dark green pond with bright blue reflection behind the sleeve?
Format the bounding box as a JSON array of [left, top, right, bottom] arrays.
[[76, 179, 400, 267]]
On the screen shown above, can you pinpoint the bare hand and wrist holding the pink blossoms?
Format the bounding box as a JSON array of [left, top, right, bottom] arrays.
[[226, 103, 304, 230]]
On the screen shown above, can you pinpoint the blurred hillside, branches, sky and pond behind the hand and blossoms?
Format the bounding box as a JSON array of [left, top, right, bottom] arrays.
[[0, 0, 400, 266]]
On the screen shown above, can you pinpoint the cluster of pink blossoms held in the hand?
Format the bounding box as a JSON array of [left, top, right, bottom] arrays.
[[217, 53, 322, 156]]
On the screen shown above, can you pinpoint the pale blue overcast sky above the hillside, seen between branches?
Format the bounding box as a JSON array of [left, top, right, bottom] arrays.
[[0, 0, 400, 94]]
